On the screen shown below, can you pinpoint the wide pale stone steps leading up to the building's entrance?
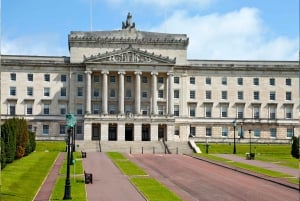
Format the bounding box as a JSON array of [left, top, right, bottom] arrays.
[[76, 141, 193, 154]]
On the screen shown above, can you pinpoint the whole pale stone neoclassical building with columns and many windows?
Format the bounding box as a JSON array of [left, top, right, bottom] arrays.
[[0, 14, 299, 141]]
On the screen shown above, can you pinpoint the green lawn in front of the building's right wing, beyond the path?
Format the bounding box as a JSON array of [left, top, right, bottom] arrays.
[[198, 144, 299, 168]]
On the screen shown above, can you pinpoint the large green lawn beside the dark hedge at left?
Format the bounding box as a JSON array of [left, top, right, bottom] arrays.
[[1, 152, 58, 201]]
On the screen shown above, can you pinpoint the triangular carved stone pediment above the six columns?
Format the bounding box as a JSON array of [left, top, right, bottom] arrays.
[[84, 45, 176, 64]]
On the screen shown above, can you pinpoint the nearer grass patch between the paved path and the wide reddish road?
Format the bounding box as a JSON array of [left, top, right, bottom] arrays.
[[130, 177, 181, 201]]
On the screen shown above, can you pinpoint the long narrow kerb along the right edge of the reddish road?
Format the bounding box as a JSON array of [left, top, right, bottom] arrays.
[[184, 154, 300, 191]]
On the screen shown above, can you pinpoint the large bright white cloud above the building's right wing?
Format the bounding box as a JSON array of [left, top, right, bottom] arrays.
[[153, 7, 299, 60]]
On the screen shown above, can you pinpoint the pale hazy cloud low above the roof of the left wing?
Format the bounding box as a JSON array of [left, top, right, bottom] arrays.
[[1, 34, 69, 56]]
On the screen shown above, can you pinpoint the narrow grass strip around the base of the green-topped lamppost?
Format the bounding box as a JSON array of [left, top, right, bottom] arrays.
[[50, 152, 86, 201]]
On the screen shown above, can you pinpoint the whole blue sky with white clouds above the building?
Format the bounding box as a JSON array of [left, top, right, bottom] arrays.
[[1, 0, 299, 60]]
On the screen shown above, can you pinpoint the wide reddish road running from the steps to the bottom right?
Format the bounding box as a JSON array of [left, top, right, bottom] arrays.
[[129, 154, 300, 201]]
